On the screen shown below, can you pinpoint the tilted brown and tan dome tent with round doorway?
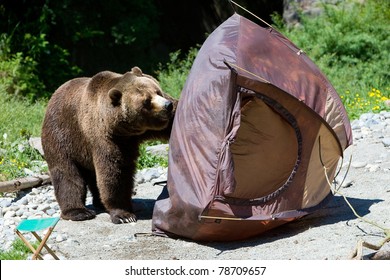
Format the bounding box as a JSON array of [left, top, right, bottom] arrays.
[[152, 14, 352, 241]]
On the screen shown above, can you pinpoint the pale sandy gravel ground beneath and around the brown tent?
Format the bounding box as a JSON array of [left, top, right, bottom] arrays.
[[49, 114, 390, 260]]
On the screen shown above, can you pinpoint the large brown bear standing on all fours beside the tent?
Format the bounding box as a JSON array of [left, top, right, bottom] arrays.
[[42, 67, 177, 224]]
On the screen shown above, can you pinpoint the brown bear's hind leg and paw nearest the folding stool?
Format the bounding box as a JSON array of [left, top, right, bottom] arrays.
[[50, 167, 96, 221]]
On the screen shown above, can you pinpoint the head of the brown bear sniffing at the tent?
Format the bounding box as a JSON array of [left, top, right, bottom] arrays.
[[93, 67, 174, 136]]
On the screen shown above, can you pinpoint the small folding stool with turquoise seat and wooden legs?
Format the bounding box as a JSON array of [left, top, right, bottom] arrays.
[[15, 217, 60, 260]]
